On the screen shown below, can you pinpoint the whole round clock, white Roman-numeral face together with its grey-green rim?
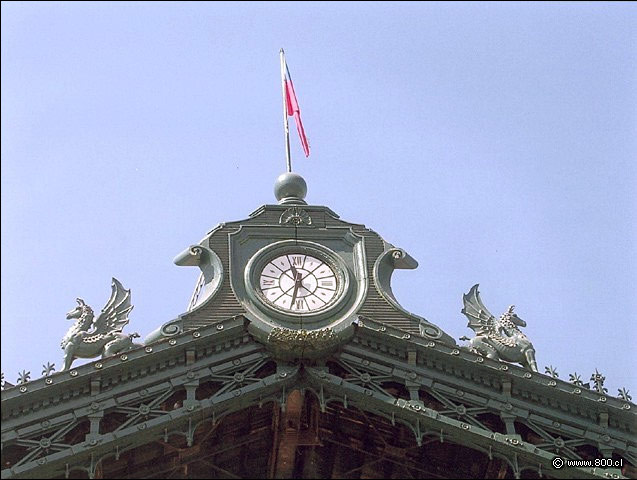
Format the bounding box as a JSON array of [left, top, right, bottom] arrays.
[[252, 246, 347, 315]]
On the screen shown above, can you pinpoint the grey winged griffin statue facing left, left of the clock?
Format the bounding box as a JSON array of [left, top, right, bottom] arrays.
[[60, 278, 140, 370]]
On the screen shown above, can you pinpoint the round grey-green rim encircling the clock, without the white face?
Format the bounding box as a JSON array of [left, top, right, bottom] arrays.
[[245, 240, 349, 318]]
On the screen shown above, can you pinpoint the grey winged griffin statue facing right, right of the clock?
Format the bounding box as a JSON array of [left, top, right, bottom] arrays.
[[460, 284, 537, 372]]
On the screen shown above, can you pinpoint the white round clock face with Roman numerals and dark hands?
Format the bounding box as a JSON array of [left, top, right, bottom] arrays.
[[259, 253, 340, 314]]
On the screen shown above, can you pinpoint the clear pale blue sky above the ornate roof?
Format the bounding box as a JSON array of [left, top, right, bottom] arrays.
[[0, 2, 637, 398]]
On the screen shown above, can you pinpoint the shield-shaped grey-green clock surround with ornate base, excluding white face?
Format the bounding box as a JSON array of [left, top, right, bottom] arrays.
[[229, 220, 369, 357]]
